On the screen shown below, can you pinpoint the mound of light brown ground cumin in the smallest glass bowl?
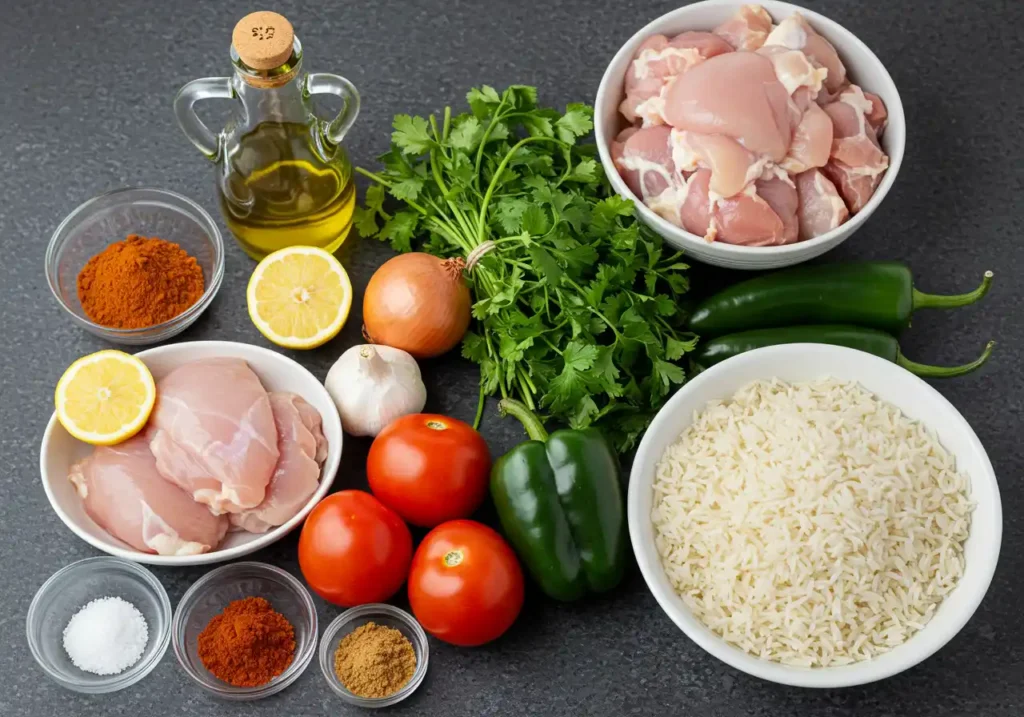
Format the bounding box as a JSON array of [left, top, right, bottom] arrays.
[[334, 622, 416, 698]]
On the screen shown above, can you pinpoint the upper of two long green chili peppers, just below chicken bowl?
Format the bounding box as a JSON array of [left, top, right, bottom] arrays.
[[690, 261, 992, 338]]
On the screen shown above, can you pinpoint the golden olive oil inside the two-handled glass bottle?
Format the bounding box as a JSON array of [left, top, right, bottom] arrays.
[[217, 121, 355, 259]]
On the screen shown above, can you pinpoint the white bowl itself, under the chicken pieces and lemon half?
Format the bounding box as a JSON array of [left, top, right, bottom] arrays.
[[39, 341, 342, 565]]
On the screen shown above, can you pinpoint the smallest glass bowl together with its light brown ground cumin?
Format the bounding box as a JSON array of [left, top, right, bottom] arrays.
[[319, 603, 430, 708]]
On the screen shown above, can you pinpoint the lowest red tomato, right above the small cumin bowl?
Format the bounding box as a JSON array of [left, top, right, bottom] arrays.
[[409, 520, 523, 647]]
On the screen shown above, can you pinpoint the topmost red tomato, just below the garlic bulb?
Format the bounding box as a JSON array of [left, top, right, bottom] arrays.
[[367, 413, 490, 528]]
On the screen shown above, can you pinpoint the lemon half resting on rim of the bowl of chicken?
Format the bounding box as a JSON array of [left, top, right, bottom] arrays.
[[53, 350, 157, 446]]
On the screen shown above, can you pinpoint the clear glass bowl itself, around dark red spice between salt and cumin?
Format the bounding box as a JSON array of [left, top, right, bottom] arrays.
[[171, 562, 316, 702]]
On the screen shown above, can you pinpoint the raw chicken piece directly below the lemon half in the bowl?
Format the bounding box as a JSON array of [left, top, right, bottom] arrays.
[[68, 435, 227, 555]]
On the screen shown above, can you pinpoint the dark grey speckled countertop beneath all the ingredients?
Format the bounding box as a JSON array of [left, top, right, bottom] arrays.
[[0, 0, 1024, 717]]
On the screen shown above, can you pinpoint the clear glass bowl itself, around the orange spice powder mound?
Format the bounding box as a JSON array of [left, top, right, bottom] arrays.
[[46, 188, 224, 346]]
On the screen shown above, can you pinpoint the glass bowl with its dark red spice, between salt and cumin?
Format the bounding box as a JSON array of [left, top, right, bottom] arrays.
[[171, 562, 317, 701]]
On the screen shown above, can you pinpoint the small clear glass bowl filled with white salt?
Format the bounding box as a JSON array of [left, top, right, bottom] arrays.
[[26, 557, 171, 694]]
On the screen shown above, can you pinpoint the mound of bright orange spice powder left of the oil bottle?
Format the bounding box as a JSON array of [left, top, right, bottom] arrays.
[[78, 235, 204, 329]]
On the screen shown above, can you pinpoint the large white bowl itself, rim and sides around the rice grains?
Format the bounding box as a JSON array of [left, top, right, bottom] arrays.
[[627, 343, 1002, 687]]
